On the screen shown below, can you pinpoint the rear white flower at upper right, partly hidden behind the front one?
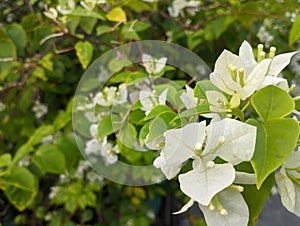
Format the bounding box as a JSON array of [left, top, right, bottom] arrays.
[[239, 41, 297, 92]]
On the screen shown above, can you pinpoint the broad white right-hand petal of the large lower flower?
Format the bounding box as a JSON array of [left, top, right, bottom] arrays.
[[202, 118, 256, 165]]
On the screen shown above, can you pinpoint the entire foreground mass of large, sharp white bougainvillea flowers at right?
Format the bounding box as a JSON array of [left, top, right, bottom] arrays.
[[153, 41, 300, 225]]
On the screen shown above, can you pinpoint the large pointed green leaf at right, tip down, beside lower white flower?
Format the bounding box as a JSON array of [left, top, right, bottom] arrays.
[[247, 119, 299, 189]]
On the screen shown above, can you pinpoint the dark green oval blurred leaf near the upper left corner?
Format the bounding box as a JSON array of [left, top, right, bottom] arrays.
[[5, 23, 28, 50]]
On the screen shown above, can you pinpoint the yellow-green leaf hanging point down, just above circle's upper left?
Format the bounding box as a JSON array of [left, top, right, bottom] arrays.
[[75, 41, 94, 69]]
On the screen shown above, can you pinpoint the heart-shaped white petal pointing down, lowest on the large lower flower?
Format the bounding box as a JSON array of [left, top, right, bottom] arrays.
[[178, 163, 235, 206]]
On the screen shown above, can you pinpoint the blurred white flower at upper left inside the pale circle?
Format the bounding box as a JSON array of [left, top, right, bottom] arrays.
[[94, 83, 128, 107]]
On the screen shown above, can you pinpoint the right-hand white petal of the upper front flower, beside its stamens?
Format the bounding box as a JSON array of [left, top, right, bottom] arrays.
[[239, 59, 271, 100]]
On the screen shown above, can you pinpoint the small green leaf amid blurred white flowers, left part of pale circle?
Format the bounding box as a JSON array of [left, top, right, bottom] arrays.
[[97, 114, 121, 138]]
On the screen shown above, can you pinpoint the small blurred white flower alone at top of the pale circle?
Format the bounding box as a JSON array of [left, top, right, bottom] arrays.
[[142, 53, 168, 75]]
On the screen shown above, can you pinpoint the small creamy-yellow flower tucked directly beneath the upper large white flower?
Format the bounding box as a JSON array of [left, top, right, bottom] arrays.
[[205, 90, 240, 112]]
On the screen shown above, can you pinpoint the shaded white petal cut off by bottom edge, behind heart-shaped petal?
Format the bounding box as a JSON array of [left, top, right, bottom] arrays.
[[199, 189, 249, 226]]
